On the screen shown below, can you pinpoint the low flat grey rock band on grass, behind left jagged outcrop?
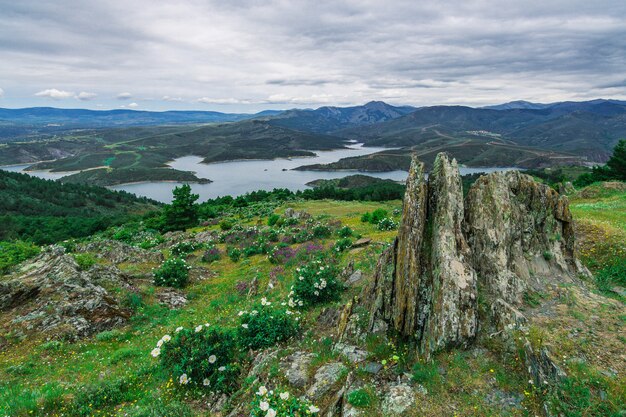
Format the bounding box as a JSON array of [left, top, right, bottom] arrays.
[[76, 240, 164, 265]]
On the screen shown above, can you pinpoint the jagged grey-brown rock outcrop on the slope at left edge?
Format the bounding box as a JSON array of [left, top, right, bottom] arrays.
[[0, 246, 130, 338]]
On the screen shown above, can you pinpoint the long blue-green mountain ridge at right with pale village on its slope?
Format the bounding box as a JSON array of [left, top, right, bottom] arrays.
[[334, 100, 626, 162]]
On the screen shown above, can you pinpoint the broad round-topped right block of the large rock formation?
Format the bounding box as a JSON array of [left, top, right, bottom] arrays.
[[465, 171, 586, 321]]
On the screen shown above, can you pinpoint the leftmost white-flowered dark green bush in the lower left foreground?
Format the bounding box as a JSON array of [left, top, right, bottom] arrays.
[[151, 324, 240, 393]]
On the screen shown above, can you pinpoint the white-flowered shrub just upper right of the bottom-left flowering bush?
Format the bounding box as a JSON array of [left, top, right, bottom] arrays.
[[237, 298, 300, 350]]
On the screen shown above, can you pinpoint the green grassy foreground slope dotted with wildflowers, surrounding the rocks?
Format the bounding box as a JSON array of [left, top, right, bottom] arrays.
[[0, 180, 626, 417]]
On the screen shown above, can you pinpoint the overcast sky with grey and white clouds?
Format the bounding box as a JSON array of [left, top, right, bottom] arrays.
[[0, 0, 626, 112]]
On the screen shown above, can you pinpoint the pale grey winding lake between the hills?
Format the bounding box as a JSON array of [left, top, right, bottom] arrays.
[[0, 144, 511, 202]]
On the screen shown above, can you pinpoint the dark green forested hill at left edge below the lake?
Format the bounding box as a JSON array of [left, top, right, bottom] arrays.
[[0, 170, 159, 244]]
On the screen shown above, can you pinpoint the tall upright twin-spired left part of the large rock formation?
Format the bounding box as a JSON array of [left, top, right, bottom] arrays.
[[370, 154, 477, 356]]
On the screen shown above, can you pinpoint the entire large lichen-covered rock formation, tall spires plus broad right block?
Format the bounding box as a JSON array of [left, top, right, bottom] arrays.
[[363, 153, 584, 357]]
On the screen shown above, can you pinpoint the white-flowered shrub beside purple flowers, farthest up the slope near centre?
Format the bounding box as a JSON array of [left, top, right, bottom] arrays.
[[289, 260, 344, 307]]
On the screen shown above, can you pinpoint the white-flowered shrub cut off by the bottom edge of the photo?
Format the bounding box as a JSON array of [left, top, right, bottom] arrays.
[[250, 385, 320, 417]]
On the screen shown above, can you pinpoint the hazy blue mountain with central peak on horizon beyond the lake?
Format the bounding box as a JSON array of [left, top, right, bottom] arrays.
[[270, 101, 415, 134]]
